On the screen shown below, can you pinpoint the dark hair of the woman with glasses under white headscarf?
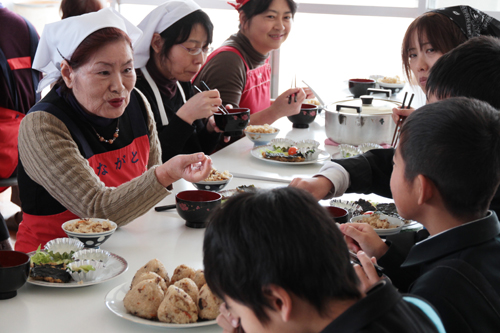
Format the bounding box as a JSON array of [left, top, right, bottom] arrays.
[[155, 9, 214, 58]]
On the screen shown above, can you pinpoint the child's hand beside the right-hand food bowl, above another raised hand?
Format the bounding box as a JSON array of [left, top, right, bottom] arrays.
[[339, 223, 389, 259]]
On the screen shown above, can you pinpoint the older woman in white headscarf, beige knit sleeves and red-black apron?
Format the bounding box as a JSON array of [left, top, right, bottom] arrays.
[[15, 8, 212, 252]]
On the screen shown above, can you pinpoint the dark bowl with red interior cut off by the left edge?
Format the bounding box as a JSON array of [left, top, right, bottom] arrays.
[[0, 251, 30, 300]]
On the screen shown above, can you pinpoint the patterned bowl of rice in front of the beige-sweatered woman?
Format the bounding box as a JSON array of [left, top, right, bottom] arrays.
[[62, 218, 117, 249]]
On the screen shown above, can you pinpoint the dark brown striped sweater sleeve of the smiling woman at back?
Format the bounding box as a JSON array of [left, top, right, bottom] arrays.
[[195, 51, 247, 107]]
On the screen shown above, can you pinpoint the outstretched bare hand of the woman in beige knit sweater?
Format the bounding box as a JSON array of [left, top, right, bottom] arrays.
[[155, 153, 212, 187]]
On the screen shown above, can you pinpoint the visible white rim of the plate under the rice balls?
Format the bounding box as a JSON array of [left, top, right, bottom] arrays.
[[104, 283, 217, 328]]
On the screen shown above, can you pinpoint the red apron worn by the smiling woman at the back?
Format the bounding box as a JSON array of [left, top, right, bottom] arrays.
[[193, 46, 271, 114]]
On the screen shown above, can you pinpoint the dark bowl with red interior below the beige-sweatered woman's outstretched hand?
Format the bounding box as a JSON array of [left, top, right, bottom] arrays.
[[175, 190, 222, 228]]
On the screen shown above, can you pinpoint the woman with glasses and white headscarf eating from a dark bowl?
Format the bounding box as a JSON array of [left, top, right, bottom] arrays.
[[134, 0, 222, 162]]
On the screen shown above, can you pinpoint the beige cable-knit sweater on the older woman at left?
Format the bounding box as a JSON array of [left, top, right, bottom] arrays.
[[19, 89, 171, 226]]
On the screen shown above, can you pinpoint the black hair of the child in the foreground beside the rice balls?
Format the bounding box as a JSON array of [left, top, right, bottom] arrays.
[[203, 187, 361, 323]]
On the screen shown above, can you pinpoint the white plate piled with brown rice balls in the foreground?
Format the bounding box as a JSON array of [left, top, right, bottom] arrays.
[[105, 259, 222, 328]]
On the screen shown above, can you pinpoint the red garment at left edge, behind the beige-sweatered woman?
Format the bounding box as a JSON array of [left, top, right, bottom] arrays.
[[0, 107, 24, 192]]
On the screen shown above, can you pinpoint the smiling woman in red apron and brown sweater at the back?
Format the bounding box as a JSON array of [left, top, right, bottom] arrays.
[[194, 0, 312, 125]]
